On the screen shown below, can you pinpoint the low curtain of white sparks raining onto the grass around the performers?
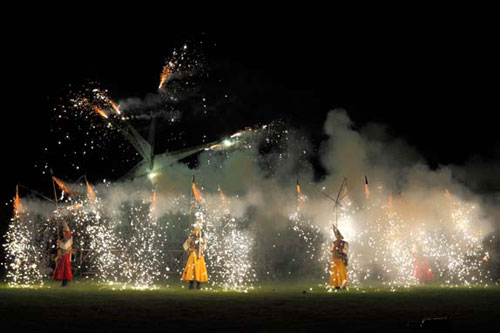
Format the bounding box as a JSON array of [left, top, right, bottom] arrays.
[[4, 152, 489, 291]]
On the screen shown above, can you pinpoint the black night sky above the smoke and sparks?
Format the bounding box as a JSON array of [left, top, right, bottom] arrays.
[[1, 19, 500, 236]]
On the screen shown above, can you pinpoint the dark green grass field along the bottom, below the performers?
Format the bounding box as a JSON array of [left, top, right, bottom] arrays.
[[0, 283, 500, 332]]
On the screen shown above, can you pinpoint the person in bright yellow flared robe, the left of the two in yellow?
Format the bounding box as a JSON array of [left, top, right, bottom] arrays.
[[182, 227, 208, 289]]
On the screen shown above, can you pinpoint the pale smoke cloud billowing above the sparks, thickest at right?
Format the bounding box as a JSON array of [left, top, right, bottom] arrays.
[[11, 109, 496, 286]]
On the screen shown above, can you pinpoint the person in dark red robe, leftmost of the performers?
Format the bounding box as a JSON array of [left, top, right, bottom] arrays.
[[52, 221, 73, 287]]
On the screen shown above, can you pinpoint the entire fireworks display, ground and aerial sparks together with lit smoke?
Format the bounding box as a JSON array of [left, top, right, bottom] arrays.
[[4, 41, 491, 292]]
